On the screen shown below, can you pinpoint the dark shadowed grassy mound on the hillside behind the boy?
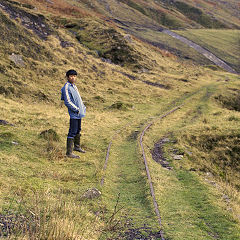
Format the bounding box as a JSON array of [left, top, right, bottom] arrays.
[[62, 19, 140, 66]]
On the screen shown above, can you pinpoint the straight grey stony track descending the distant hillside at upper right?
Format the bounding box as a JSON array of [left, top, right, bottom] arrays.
[[161, 29, 237, 74]]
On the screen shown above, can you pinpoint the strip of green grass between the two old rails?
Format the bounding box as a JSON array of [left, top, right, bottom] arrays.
[[99, 136, 158, 239]]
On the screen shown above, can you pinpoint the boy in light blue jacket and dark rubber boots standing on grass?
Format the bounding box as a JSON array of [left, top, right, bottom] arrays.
[[61, 69, 86, 158]]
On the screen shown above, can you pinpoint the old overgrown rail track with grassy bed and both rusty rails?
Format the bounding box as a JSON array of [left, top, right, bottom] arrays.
[[98, 86, 205, 240]]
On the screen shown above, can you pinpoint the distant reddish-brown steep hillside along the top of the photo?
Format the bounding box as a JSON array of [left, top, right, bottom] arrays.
[[7, 0, 240, 70]]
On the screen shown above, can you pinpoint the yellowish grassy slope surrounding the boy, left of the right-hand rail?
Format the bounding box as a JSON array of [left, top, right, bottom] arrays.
[[0, 0, 239, 239]]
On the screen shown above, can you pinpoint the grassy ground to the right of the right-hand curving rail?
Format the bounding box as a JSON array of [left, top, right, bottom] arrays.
[[141, 74, 239, 239]]
